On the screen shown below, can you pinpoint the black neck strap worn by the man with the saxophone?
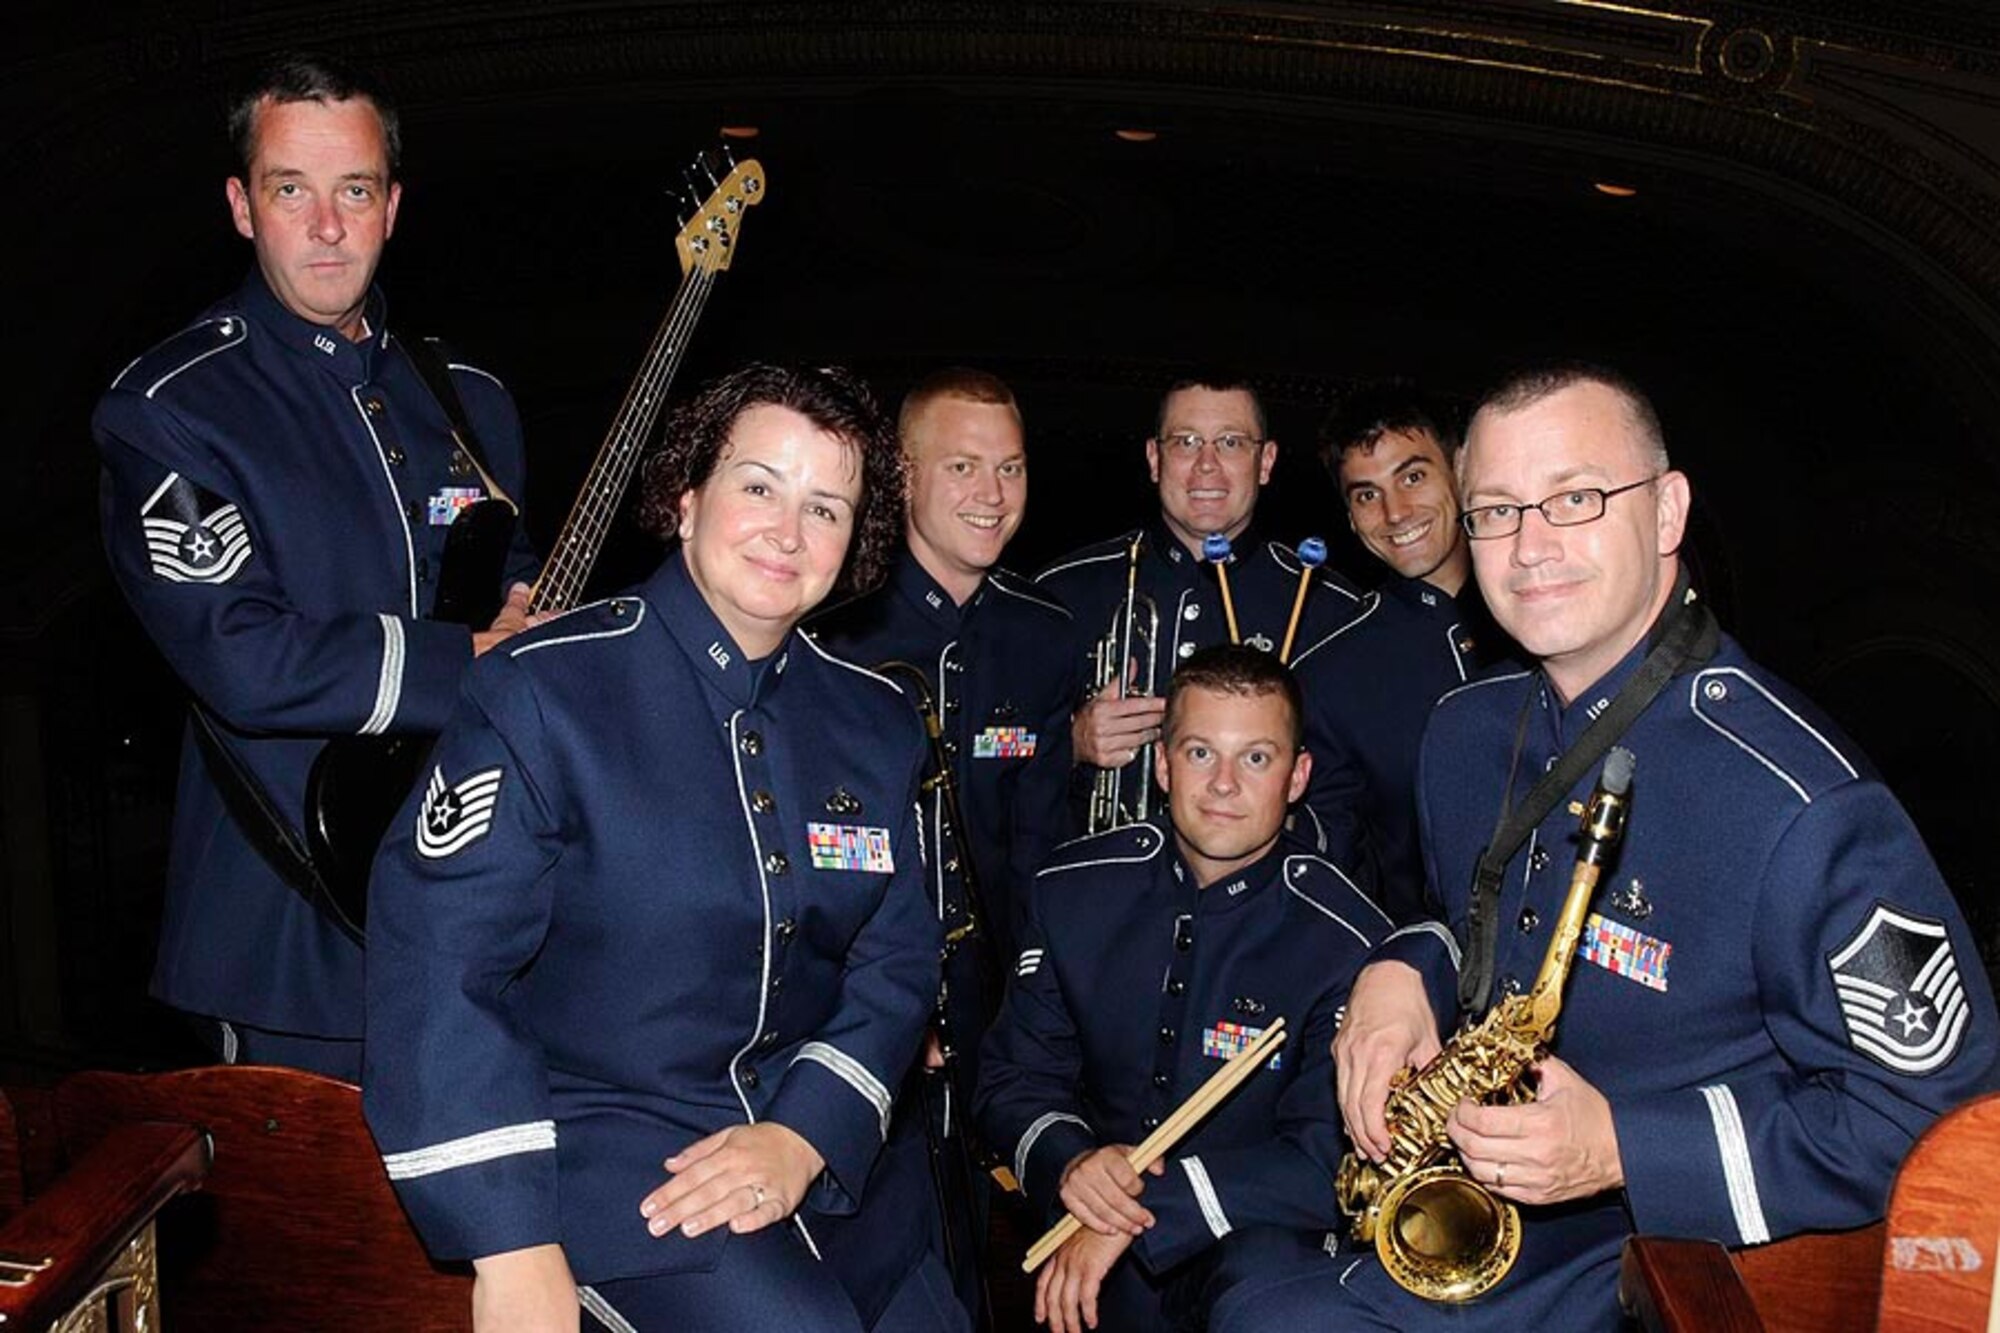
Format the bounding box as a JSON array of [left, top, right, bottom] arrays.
[[1458, 570, 1722, 1019]]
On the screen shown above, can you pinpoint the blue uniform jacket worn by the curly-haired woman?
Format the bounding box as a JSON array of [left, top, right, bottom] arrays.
[[364, 550, 940, 1283]]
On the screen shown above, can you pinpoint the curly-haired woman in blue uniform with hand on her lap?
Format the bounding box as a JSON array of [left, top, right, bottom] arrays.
[[364, 366, 940, 1333]]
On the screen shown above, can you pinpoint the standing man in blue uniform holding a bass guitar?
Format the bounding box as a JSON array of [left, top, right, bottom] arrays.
[[92, 56, 534, 1079]]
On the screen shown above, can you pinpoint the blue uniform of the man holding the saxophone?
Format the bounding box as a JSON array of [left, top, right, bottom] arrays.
[[1228, 636, 1996, 1329]]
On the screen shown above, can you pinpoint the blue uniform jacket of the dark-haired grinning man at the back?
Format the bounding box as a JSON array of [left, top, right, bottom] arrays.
[[1292, 576, 1512, 921]]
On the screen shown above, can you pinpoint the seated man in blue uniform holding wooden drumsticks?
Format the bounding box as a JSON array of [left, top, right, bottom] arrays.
[[974, 644, 1388, 1333]]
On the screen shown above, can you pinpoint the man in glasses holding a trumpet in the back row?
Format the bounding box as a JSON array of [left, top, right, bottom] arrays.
[[1036, 376, 1360, 840]]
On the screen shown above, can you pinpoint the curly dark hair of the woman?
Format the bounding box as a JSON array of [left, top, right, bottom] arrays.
[[638, 360, 904, 596]]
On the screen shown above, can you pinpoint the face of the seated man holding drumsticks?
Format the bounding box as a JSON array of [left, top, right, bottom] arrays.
[[1154, 685, 1312, 887]]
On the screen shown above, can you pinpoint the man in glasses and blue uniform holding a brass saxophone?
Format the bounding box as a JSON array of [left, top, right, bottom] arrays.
[[1214, 366, 1996, 1333]]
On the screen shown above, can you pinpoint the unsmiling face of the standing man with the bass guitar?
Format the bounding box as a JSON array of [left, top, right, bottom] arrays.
[[226, 98, 402, 340]]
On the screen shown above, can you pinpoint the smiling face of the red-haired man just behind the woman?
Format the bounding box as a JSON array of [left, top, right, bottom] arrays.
[[902, 396, 1028, 602]]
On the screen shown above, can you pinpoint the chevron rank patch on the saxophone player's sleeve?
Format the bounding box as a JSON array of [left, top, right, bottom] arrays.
[[1826, 903, 1972, 1075]]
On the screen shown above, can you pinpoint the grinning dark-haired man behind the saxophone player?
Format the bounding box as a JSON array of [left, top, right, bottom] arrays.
[[1292, 382, 1508, 921]]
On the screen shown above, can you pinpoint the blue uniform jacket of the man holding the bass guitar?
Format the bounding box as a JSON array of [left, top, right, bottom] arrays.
[[92, 272, 532, 1037]]
